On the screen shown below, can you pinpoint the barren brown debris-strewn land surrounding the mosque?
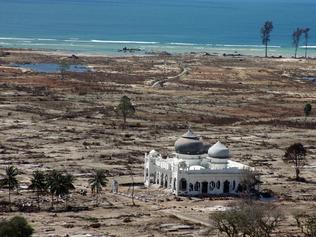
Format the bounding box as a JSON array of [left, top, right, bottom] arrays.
[[0, 50, 316, 236]]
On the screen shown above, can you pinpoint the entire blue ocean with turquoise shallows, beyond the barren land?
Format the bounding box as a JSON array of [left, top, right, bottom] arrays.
[[0, 0, 316, 56]]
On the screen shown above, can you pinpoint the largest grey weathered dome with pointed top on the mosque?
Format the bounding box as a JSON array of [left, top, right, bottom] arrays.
[[175, 129, 204, 155]]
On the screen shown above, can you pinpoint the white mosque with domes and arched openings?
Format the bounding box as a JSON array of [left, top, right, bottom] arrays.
[[144, 129, 251, 196]]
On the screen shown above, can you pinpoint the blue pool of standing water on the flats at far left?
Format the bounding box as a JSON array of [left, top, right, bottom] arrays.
[[11, 63, 91, 73]]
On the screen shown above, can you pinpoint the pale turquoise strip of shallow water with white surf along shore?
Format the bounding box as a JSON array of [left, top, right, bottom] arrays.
[[0, 37, 316, 58]]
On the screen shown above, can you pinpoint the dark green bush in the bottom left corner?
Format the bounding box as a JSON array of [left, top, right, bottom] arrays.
[[0, 216, 34, 237]]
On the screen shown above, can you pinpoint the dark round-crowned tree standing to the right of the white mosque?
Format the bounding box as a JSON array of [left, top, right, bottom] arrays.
[[283, 143, 306, 181]]
